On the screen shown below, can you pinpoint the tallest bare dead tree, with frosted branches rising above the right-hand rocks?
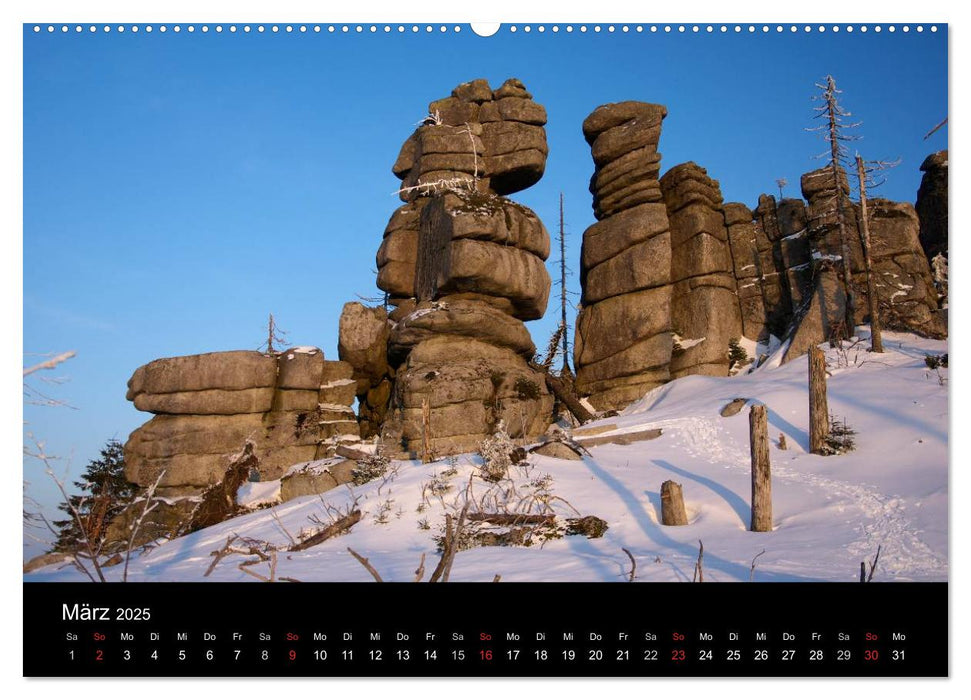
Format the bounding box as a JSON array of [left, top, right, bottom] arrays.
[[808, 75, 859, 335]]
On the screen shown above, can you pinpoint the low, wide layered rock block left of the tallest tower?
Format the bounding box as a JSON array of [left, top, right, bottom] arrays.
[[125, 347, 359, 497]]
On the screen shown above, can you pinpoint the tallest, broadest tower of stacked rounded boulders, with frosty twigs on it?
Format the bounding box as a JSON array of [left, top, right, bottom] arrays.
[[372, 79, 552, 455]]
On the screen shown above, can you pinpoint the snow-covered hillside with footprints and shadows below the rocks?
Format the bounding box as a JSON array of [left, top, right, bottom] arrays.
[[24, 333, 948, 582]]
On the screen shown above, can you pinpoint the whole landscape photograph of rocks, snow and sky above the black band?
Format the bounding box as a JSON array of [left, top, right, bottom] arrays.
[[22, 22, 949, 596]]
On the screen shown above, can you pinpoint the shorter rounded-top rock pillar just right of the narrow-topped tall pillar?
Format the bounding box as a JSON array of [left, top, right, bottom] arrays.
[[660, 162, 742, 379]]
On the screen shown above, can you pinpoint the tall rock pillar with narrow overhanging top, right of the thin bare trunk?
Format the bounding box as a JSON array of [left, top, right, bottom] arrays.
[[573, 102, 672, 409]]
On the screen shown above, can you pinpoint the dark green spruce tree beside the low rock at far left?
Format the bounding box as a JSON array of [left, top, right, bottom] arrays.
[[53, 439, 138, 552]]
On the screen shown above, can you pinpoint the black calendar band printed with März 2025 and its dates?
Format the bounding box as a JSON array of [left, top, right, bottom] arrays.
[[24, 583, 948, 678]]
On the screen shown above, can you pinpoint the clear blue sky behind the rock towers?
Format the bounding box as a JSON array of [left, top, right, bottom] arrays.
[[23, 25, 948, 540]]
